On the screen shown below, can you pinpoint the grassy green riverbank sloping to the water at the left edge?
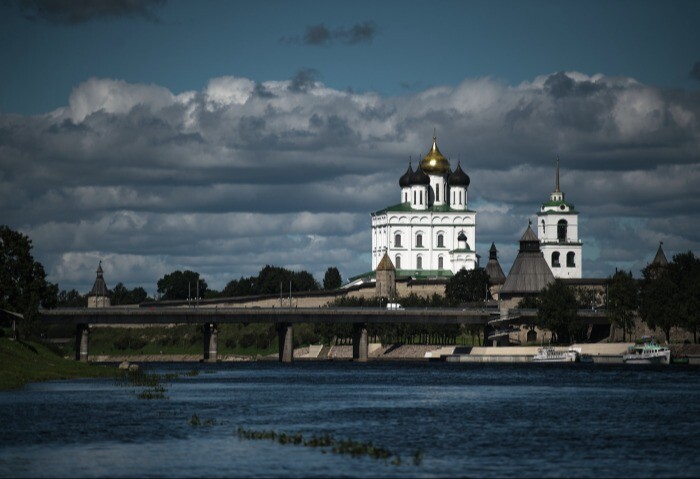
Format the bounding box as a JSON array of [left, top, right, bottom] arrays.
[[0, 338, 116, 390]]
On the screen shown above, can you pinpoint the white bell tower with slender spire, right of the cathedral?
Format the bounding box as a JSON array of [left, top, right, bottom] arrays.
[[537, 158, 583, 278]]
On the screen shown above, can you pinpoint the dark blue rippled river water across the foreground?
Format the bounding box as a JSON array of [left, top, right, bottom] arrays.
[[0, 361, 700, 478]]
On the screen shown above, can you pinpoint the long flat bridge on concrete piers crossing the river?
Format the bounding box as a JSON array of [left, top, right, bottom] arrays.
[[39, 306, 608, 363]]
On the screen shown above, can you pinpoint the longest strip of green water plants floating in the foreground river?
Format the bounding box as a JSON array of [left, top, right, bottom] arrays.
[[237, 427, 423, 466]]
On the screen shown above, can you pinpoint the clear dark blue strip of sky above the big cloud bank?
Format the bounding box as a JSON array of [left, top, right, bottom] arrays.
[[0, 0, 700, 114]]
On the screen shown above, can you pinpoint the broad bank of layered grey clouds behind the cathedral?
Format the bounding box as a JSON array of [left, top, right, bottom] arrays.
[[0, 70, 700, 291]]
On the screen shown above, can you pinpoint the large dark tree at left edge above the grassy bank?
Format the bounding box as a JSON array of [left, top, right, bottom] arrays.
[[0, 225, 58, 337]]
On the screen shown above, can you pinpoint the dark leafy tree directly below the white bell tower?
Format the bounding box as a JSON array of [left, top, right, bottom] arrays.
[[536, 278, 582, 342]]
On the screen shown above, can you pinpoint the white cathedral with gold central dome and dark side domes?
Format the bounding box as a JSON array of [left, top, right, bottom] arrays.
[[371, 136, 479, 278]]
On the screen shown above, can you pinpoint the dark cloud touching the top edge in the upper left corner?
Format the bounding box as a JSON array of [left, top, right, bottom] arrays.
[[18, 0, 165, 25]]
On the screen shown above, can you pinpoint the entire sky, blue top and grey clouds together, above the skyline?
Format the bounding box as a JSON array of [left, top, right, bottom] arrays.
[[0, 0, 700, 295]]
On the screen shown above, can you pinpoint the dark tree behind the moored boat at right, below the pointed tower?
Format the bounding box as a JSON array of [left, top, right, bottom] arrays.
[[639, 263, 680, 342]]
